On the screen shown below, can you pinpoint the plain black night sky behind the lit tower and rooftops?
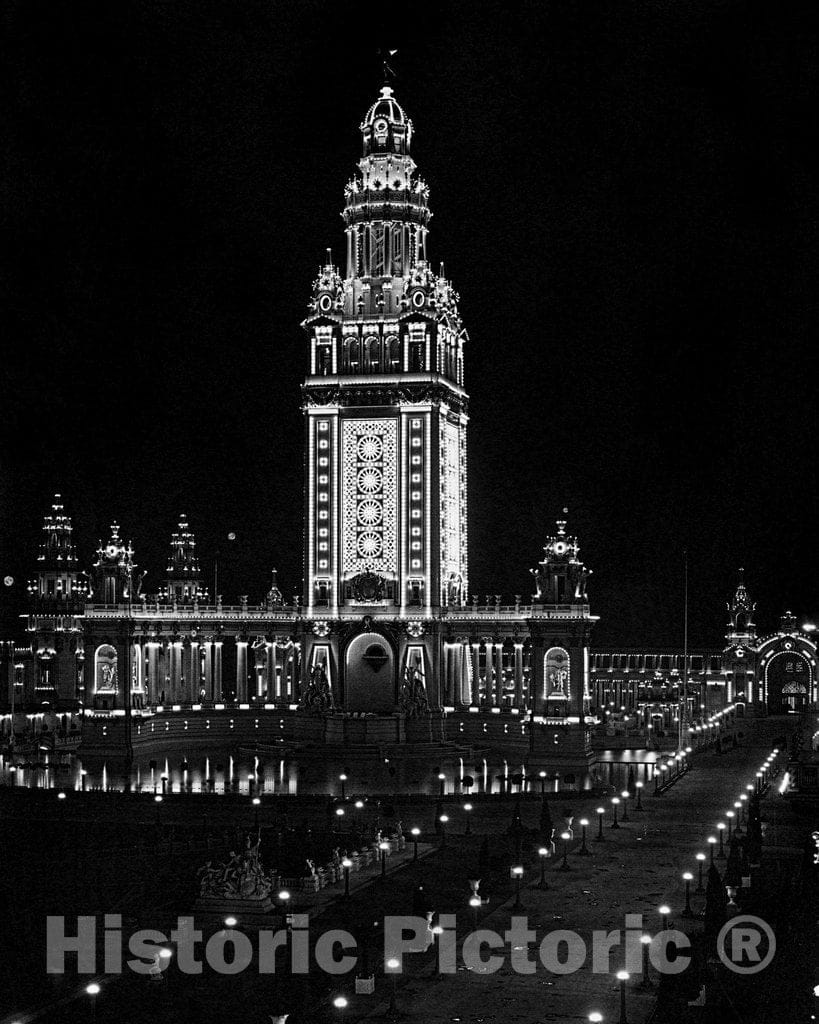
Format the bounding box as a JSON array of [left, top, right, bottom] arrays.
[[0, 0, 819, 645]]
